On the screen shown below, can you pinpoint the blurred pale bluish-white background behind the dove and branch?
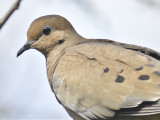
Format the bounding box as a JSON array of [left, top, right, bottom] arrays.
[[0, 0, 160, 120]]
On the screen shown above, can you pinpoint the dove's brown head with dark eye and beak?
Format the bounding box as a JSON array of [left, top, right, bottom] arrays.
[[17, 15, 78, 57]]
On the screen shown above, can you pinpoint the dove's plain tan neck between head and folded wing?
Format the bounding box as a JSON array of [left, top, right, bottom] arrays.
[[45, 32, 85, 89]]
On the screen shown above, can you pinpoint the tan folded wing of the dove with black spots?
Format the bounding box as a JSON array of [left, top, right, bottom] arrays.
[[52, 42, 160, 120]]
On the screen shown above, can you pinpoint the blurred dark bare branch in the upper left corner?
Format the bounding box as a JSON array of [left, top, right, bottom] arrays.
[[0, 0, 22, 29]]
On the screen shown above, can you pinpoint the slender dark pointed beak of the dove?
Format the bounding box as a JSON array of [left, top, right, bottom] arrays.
[[17, 41, 35, 57]]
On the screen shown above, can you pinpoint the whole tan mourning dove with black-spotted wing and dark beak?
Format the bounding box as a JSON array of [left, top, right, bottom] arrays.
[[17, 15, 160, 120]]
